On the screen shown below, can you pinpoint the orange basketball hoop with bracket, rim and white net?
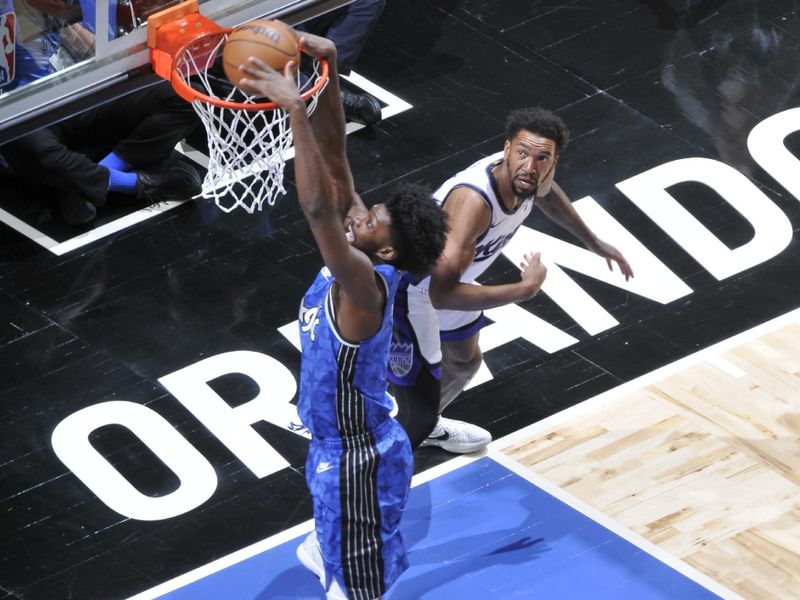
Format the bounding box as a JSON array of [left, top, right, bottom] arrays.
[[148, 0, 328, 213]]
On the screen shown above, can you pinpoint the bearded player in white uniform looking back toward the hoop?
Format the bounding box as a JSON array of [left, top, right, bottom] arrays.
[[388, 107, 633, 453]]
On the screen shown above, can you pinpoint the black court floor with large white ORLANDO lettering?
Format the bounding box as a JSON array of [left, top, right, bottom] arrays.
[[0, 0, 800, 600]]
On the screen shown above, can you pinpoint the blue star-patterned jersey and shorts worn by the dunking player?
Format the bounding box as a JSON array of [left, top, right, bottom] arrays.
[[297, 265, 414, 598]]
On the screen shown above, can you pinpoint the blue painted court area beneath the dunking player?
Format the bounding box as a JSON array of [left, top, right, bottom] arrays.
[[163, 458, 717, 600]]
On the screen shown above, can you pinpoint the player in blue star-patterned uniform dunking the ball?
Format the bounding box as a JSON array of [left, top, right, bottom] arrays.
[[239, 29, 447, 600]]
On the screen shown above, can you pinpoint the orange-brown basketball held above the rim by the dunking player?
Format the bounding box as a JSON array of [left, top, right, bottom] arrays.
[[222, 19, 300, 85]]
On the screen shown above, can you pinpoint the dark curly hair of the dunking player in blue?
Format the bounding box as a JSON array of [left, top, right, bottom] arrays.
[[384, 183, 450, 277]]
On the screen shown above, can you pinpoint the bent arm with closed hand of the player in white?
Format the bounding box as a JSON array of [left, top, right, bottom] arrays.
[[429, 188, 547, 310]]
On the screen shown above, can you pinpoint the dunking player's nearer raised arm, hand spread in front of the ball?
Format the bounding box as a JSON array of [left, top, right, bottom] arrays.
[[239, 54, 384, 316]]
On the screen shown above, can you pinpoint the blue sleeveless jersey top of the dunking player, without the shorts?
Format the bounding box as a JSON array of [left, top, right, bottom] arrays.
[[297, 265, 401, 441]]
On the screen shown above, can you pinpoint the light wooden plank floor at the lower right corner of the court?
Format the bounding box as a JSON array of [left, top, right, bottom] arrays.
[[503, 316, 800, 599]]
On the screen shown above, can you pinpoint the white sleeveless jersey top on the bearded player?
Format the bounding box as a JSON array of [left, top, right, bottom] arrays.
[[432, 151, 533, 287]]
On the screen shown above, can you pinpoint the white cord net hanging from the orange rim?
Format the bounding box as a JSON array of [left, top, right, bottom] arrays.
[[176, 35, 327, 213]]
